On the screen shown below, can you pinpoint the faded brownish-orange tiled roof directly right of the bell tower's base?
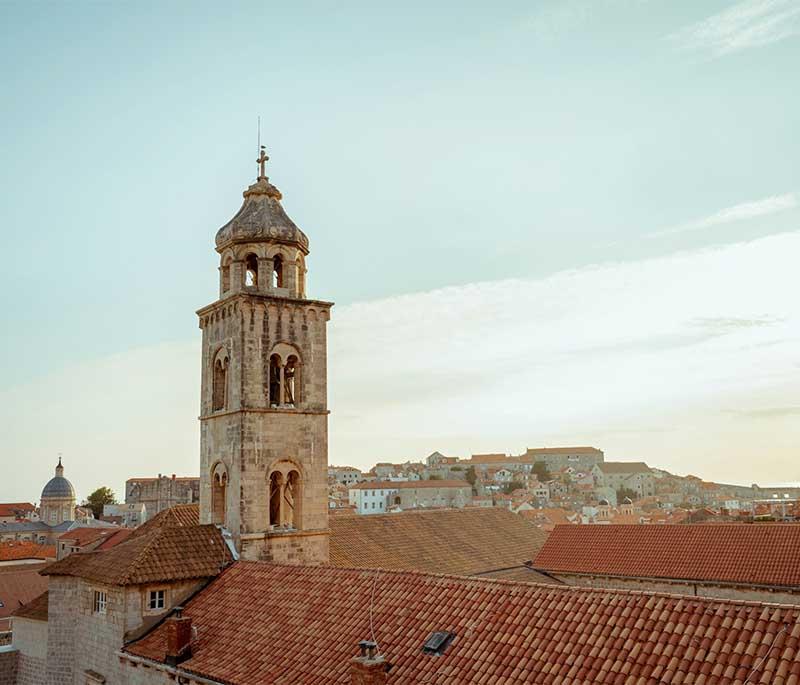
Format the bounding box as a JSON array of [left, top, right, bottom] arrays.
[[329, 507, 546, 576]]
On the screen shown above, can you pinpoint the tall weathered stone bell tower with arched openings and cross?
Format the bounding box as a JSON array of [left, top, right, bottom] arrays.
[[197, 147, 333, 564]]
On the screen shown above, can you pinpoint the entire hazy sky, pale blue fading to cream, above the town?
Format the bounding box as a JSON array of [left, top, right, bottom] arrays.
[[0, 0, 800, 501]]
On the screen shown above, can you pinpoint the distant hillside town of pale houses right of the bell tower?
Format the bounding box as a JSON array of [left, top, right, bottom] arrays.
[[328, 447, 800, 528]]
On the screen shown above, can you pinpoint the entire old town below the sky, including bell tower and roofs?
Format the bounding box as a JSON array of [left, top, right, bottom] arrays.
[[0, 140, 800, 685]]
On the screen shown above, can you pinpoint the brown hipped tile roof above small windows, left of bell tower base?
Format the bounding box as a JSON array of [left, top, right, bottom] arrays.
[[42, 525, 231, 585]]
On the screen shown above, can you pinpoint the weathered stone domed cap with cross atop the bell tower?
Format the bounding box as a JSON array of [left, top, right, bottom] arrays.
[[216, 146, 308, 254]]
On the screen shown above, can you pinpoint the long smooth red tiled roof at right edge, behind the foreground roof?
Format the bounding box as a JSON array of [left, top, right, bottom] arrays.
[[533, 523, 800, 587]]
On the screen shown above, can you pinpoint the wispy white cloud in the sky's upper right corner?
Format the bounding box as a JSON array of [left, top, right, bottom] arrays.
[[668, 0, 800, 57]]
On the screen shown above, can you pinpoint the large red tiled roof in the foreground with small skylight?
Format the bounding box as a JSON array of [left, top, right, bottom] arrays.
[[125, 562, 800, 685]]
